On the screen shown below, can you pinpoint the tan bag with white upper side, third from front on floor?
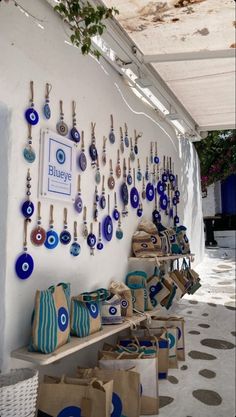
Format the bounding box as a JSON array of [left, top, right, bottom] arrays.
[[99, 351, 159, 415]]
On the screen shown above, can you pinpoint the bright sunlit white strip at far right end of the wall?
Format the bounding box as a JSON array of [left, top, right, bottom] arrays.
[[179, 140, 204, 263]]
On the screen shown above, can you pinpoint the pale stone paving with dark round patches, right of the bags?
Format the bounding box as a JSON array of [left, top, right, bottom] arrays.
[[143, 249, 236, 417]]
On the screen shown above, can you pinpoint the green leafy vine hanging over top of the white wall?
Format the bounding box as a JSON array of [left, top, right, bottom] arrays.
[[54, 0, 119, 59]]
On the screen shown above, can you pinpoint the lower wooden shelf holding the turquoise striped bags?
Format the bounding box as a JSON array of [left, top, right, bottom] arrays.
[[11, 315, 146, 365]]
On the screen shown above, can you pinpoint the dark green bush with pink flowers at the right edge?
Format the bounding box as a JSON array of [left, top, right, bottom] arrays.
[[194, 130, 236, 191]]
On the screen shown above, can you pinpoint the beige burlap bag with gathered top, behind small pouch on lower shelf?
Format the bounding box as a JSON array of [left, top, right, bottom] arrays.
[[108, 281, 133, 317]]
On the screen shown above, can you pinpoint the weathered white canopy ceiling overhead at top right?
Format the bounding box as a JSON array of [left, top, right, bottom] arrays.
[[104, 0, 235, 130]]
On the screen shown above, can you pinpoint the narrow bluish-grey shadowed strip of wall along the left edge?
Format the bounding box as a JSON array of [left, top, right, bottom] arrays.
[[0, 102, 10, 371]]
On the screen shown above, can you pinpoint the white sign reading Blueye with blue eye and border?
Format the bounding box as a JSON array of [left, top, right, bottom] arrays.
[[39, 130, 76, 202]]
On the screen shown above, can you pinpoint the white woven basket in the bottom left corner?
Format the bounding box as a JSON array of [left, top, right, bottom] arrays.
[[0, 368, 38, 417]]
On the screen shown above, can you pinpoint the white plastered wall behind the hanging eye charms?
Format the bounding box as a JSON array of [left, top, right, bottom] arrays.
[[0, 0, 203, 369]]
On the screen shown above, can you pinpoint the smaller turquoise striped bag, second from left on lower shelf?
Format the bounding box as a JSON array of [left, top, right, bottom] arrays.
[[71, 288, 109, 337]]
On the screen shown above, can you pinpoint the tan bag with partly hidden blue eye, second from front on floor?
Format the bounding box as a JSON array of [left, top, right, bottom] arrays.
[[77, 368, 140, 417]]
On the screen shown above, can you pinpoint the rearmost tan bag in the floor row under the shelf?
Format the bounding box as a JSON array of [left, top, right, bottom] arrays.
[[148, 316, 185, 361]]
